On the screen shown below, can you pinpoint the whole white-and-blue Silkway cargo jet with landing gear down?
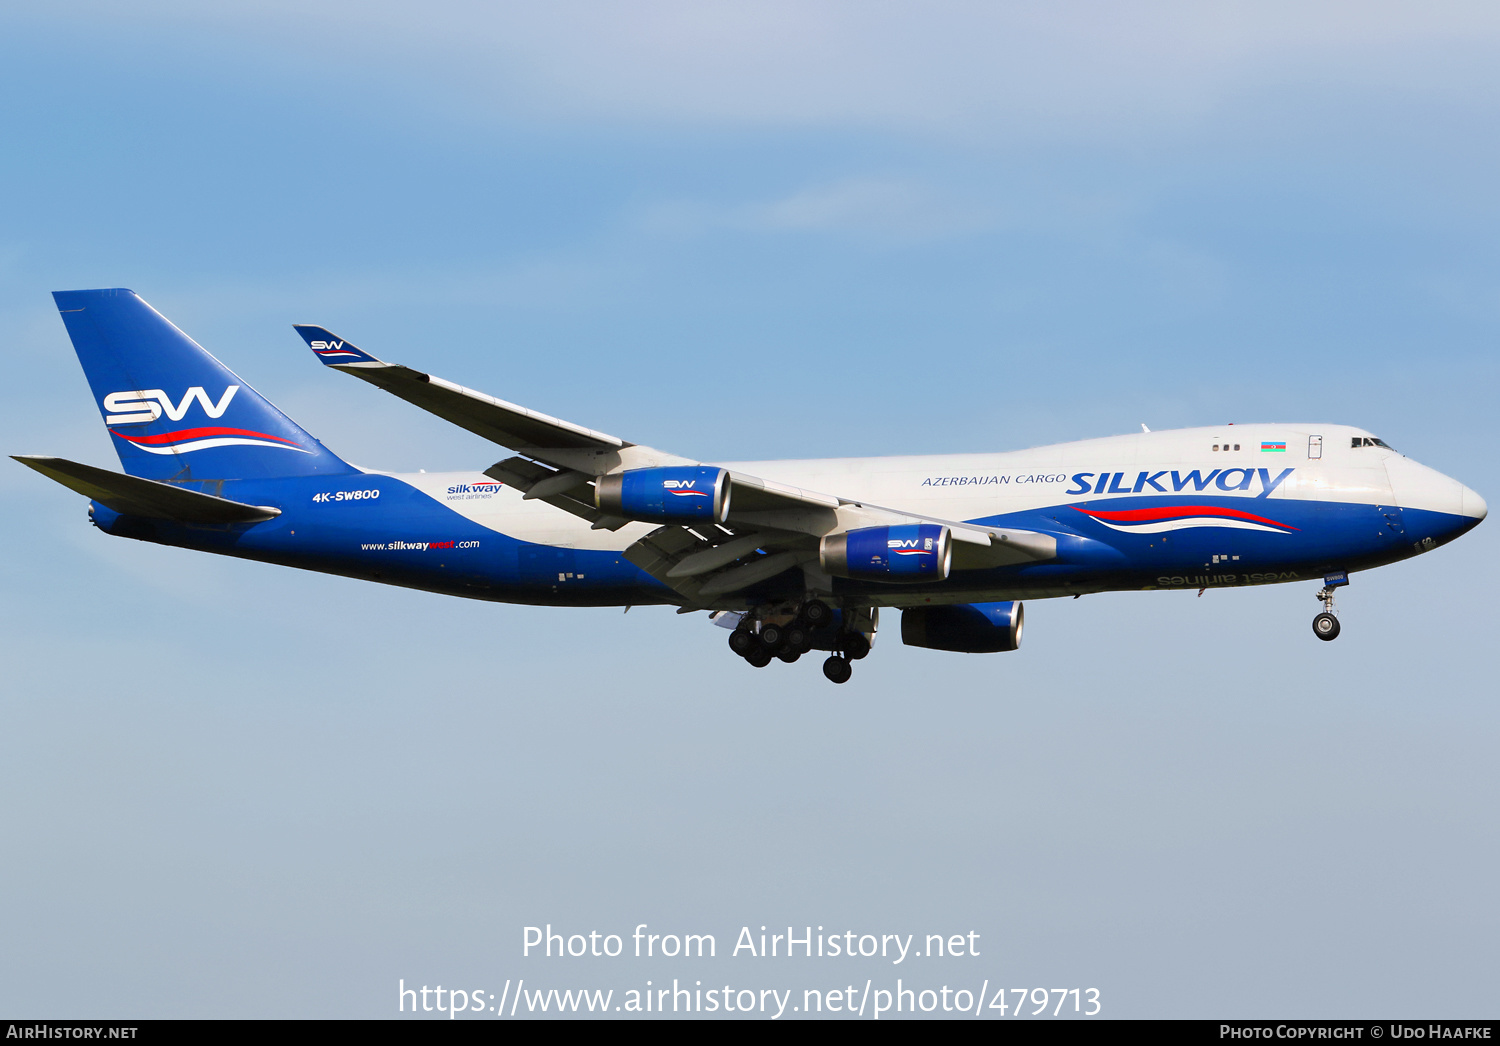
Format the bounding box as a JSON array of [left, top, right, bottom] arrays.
[[17, 290, 1487, 683]]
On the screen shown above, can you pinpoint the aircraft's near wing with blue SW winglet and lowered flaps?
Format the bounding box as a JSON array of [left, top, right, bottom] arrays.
[[294, 324, 1056, 602]]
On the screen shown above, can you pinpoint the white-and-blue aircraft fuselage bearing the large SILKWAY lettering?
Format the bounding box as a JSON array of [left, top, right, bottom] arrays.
[[93, 425, 1485, 608]]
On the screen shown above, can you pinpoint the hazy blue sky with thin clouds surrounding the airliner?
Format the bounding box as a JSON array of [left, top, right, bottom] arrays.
[[0, 3, 1500, 1016]]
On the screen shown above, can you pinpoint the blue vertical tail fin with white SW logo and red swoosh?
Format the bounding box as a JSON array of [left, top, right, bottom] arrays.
[[53, 290, 356, 480]]
